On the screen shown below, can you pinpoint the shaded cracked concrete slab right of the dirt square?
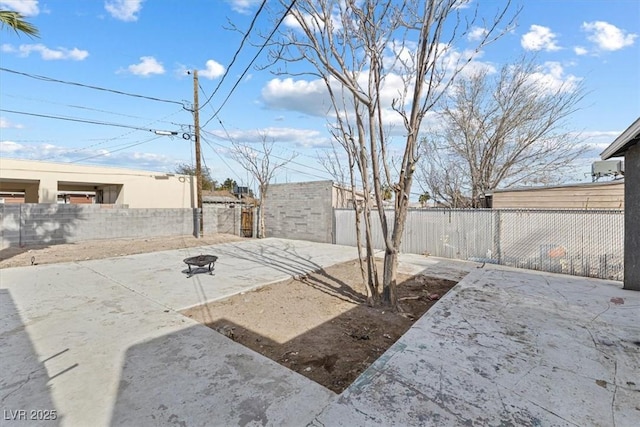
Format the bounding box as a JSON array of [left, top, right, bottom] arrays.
[[312, 267, 640, 427]]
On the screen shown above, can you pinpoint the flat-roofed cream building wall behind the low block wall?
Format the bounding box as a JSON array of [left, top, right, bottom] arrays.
[[0, 158, 197, 208]]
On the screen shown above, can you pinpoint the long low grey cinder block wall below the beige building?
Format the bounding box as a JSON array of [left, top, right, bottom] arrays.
[[0, 204, 196, 248]]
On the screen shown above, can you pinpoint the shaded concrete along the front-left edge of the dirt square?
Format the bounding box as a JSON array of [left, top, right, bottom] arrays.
[[110, 325, 332, 426]]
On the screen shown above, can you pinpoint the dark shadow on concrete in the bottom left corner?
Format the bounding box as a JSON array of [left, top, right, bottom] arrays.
[[0, 289, 61, 426]]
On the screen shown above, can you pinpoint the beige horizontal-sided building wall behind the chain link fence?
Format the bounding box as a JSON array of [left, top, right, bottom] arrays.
[[493, 181, 624, 209]]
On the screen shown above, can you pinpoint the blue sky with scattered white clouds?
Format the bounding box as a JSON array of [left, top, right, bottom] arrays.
[[0, 0, 640, 196]]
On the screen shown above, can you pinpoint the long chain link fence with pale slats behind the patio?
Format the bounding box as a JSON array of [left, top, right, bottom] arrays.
[[335, 209, 624, 280]]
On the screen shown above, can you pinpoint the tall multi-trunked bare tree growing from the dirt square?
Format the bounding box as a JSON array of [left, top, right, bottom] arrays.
[[271, 0, 510, 308]]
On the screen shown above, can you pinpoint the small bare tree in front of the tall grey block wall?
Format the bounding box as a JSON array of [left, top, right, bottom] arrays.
[[230, 133, 297, 238]]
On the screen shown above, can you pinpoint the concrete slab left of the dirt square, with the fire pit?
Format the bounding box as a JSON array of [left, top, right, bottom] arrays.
[[0, 239, 355, 426]]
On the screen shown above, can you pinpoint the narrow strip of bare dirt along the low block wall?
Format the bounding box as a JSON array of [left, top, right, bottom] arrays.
[[0, 234, 245, 268]]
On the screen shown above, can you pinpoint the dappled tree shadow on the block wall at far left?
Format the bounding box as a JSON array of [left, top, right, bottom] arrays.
[[0, 203, 85, 264]]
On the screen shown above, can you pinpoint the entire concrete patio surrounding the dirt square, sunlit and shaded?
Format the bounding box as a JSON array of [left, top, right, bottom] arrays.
[[0, 239, 640, 426]]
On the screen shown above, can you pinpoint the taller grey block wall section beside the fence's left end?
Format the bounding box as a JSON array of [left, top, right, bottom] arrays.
[[262, 181, 333, 243]]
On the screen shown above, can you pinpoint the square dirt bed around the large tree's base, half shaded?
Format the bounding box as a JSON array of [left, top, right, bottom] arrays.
[[183, 261, 456, 393]]
